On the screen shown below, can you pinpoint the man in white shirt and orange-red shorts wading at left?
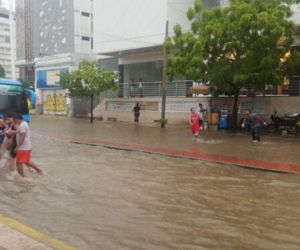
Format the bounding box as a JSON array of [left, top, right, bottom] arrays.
[[13, 114, 42, 177]]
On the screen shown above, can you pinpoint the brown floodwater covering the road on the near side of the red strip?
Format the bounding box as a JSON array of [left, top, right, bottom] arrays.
[[0, 118, 300, 250]]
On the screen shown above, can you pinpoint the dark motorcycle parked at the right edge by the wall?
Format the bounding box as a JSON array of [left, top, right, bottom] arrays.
[[266, 110, 300, 134]]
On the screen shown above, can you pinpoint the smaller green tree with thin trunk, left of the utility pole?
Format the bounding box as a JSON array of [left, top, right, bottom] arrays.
[[60, 61, 116, 123]]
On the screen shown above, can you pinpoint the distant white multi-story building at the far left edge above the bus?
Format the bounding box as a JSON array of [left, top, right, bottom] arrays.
[[0, 8, 18, 79]]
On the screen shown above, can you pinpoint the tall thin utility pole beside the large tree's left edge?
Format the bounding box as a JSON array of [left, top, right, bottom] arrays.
[[160, 21, 169, 128]]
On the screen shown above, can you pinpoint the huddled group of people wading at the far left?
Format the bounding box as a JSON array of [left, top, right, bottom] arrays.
[[0, 114, 42, 177]]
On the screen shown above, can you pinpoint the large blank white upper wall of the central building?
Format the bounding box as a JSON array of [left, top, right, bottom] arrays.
[[94, 0, 167, 54]]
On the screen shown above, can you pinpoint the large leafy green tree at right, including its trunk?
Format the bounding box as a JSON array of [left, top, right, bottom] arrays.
[[165, 0, 299, 129]]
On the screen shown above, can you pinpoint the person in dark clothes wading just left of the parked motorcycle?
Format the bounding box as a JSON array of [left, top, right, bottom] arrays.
[[241, 109, 263, 142]]
